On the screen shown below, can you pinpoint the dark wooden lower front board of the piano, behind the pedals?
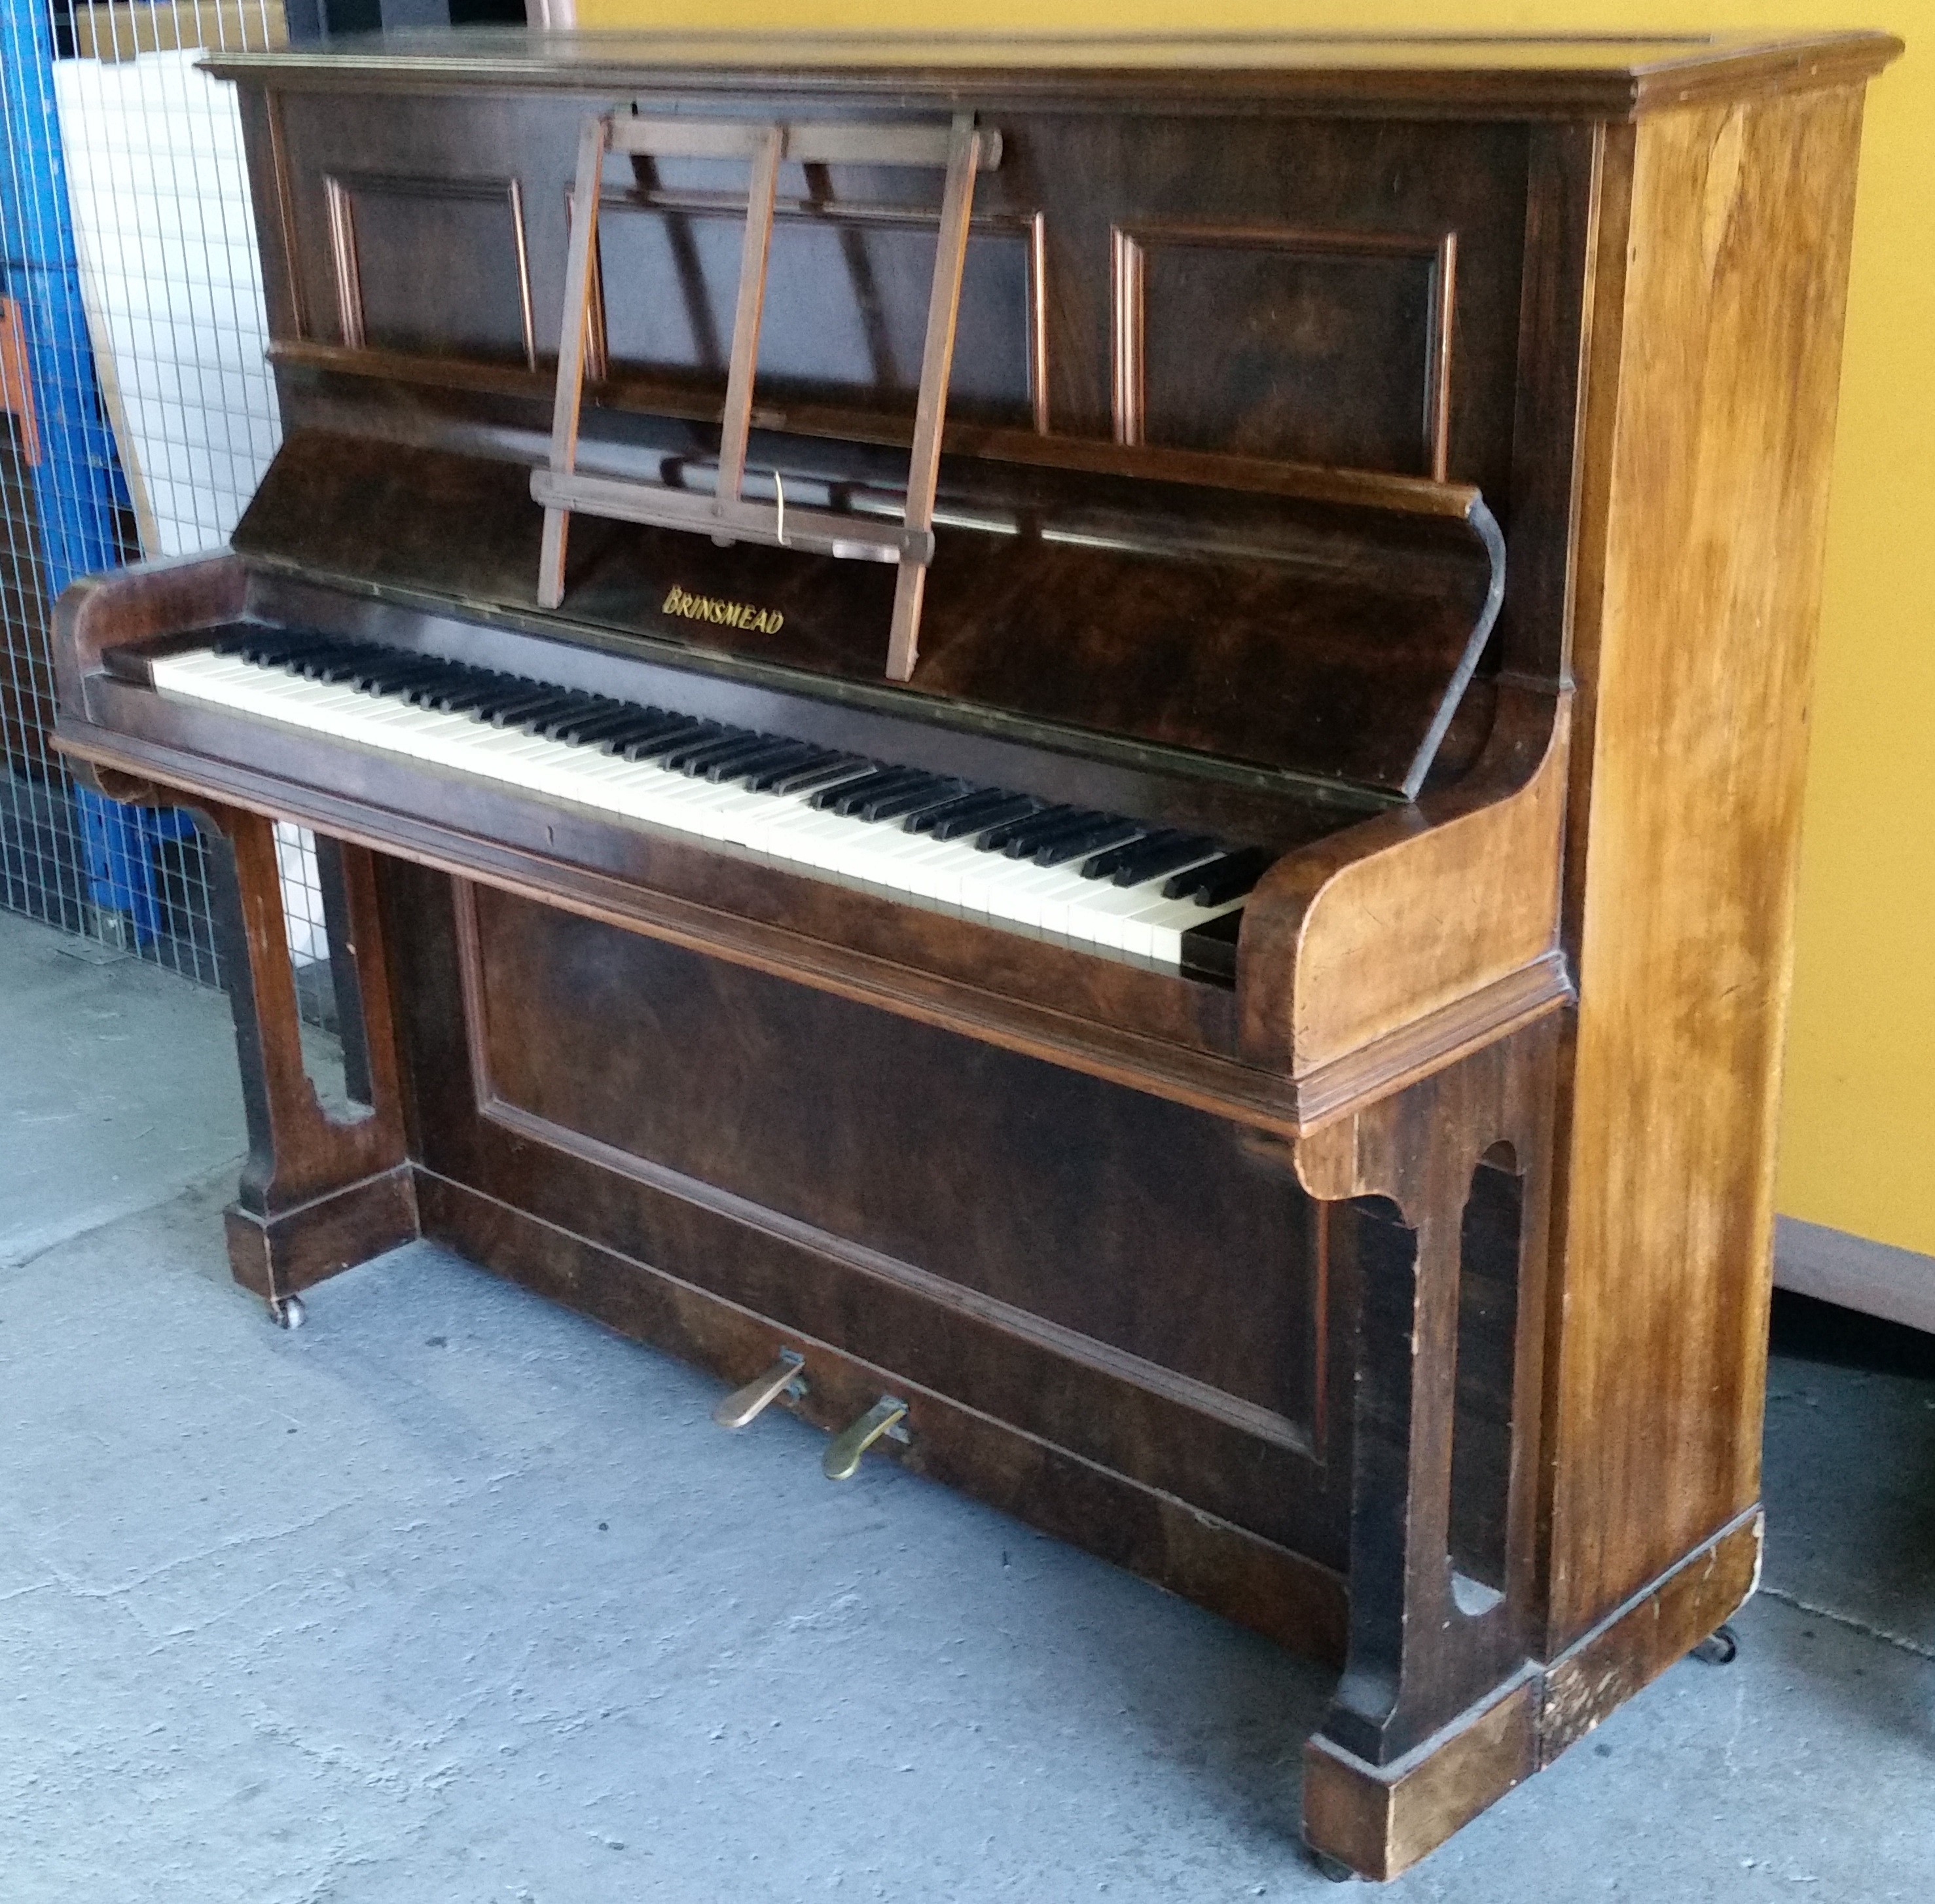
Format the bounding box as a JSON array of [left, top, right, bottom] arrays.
[[381, 861, 1352, 1625]]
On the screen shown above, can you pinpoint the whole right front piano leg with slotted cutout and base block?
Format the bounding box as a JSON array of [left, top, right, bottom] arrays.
[[1297, 1017, 1558, 1879]]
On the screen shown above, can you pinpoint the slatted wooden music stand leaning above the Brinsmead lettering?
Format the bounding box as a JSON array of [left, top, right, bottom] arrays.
[[530, 112, 1000, 681]]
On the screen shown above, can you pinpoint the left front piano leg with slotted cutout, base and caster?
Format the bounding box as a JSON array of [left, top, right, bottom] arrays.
[[198, 807, 418, 1320]]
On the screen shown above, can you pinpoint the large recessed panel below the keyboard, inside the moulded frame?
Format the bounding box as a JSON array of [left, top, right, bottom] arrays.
[[470, 890, 1322, 1446]]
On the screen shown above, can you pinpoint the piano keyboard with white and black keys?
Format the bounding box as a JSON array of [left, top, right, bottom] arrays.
[[149, 625, 1271, 977]]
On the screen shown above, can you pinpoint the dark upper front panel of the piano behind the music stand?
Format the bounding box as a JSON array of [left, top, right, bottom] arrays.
[[265, 91, 1530, 499]]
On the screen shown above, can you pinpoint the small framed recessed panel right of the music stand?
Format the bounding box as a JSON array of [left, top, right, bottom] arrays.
[[1117, 230, 1449, 476]]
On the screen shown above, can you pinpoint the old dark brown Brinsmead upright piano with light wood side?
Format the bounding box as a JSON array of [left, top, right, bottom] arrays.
[[58, 33, 1898, 1877]]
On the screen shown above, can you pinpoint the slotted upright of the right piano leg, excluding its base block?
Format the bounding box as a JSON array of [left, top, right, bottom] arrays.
[[1295, 1019, 1558, 1765]]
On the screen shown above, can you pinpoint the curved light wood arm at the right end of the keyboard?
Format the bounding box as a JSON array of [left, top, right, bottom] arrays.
[[1239, 689, 1567, 1076]]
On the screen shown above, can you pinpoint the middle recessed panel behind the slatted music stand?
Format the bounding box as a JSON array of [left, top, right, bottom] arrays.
[[598, 203, 1035, 428]]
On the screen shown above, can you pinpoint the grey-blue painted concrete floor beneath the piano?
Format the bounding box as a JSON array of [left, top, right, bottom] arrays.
[[0, 917, 1935, 1904]]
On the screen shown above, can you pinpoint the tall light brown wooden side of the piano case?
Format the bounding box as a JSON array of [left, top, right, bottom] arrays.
[[1548, 91, 1862, 1657]]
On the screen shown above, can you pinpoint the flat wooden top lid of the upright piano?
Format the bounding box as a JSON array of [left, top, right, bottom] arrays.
[[203, 27, 1902, 118]]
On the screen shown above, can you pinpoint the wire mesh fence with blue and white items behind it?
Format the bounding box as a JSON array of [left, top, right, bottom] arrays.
[[0, 0, 329, 1017]]
